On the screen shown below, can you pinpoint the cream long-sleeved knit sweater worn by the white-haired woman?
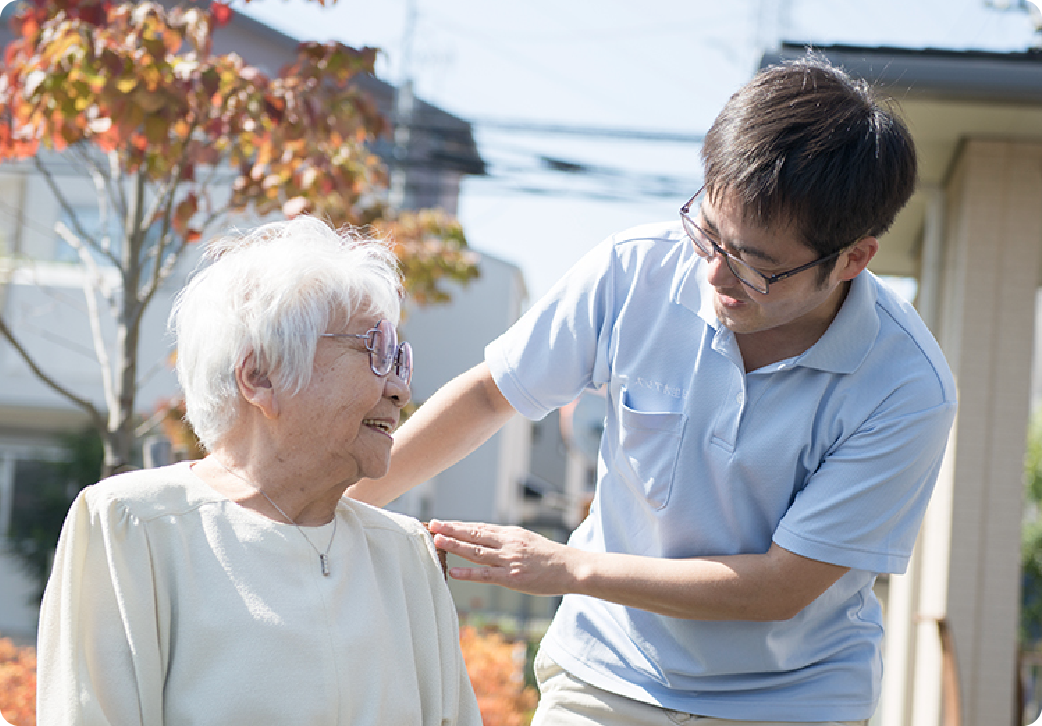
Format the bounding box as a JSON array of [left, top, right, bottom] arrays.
[[38, 464, 480, 726]]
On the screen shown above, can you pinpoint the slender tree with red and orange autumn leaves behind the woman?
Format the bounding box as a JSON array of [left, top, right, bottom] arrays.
[[0, 0, 476, 474]]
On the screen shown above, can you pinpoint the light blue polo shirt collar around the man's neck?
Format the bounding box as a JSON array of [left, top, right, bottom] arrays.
[[674, 255, 879, 373]]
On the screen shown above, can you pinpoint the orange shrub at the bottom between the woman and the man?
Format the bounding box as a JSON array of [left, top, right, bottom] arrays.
[[460, 625, 538, 726]]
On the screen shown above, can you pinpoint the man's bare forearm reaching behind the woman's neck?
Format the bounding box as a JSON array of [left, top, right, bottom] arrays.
[[348, 362, 516, 506]]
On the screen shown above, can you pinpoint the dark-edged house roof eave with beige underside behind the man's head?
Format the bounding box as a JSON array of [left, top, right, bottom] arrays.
[[760, 43, 1042, 276]]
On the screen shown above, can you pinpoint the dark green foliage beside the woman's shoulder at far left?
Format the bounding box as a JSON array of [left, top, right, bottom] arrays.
[[7, 428, 104, 599]]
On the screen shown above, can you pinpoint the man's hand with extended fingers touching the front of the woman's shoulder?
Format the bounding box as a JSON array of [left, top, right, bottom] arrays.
[[429, 520, 584, 595]]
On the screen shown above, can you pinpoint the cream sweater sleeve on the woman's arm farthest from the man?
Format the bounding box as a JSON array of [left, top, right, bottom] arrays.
[[36, 487, 166, 726]]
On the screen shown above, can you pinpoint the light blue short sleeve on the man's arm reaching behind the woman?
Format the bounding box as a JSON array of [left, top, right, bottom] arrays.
[[485, 237, 617, 420]]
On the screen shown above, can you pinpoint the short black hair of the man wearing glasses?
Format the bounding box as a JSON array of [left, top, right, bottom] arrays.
[[702, 53, 916, 279]]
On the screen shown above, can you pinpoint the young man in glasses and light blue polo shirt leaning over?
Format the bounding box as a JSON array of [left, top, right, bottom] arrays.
[[352, 56, 956, 726]]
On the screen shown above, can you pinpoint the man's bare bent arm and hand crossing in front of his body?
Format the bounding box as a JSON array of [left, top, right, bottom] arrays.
[[430, 522, 848, 621]]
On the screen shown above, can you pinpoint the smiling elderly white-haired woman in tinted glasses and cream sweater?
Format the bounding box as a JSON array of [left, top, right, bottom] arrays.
[[38, 219, 480, 726]]
